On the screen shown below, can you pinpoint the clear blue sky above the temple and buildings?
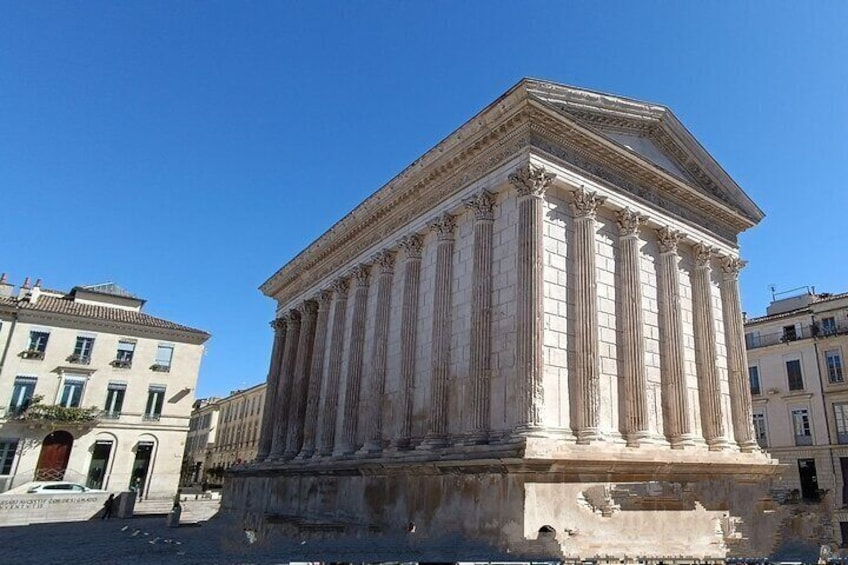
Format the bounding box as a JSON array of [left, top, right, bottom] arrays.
[[0, 0, 848, 396]]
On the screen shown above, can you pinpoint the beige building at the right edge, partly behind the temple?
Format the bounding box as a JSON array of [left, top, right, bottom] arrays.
[[745, 289, 848, 544]]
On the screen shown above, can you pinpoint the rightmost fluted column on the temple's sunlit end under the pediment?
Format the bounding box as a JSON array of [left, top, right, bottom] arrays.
[[721, 257, 760, 452]]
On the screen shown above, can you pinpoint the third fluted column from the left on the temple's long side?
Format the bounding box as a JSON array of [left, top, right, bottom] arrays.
[[283, 300, 318, 459]]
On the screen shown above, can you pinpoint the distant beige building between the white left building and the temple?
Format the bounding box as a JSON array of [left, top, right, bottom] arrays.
[[183, 383, 266, 486]]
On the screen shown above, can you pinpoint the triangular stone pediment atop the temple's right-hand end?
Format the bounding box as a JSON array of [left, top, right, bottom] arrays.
[[523, 79, 763, 222]]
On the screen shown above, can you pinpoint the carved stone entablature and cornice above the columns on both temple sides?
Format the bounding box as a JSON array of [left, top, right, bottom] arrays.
[[260, 81, 756, 305]]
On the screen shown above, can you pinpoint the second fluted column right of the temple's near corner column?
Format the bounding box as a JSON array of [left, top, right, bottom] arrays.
[[616, 208, 651, 447]]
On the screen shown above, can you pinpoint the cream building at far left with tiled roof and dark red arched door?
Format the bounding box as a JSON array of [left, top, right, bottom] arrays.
[[0, 276, 209, 498]]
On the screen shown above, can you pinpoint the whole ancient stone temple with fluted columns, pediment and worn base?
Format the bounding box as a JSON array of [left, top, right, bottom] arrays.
[[224, 79, 778, 560]]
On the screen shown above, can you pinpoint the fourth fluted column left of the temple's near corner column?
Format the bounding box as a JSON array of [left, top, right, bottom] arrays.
[[363, 249, 395, 453]]
